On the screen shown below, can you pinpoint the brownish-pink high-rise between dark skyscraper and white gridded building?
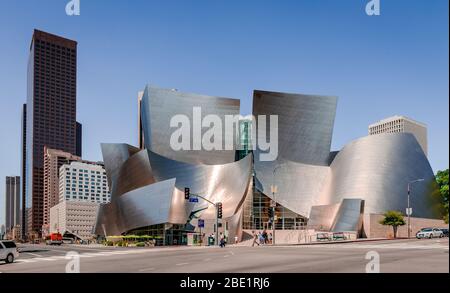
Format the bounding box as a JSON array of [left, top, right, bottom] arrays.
[[44, 147, 81, 226]]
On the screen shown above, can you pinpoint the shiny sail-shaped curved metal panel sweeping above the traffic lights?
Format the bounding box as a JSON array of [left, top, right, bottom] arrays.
[[148, 151, 252, 219]]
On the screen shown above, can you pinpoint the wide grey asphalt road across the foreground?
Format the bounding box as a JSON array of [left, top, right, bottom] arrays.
[[0, 238, 449, 273]]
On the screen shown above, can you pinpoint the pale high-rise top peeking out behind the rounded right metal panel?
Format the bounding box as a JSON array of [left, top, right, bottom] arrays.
[[369, 116, 428, 156]]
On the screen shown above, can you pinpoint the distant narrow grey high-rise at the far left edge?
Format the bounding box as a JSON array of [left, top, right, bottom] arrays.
[[5, 176, 21, 233]]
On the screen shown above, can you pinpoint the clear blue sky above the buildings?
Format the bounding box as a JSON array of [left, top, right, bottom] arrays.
[[0, 0, 449, 223]]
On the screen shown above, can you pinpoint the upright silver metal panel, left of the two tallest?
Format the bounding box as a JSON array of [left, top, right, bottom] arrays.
[[141, 86, 240, 165]]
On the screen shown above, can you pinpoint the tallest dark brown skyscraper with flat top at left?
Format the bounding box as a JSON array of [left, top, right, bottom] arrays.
[[22, 30, 82, 238]]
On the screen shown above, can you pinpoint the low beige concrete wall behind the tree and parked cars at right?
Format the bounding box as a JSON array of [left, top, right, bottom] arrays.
[[364, 214, 448, 238]]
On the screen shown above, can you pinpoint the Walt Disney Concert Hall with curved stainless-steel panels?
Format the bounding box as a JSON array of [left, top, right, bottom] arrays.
[[95, 86, 435, 245]]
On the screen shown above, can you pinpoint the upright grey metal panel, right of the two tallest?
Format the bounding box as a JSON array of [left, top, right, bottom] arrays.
[[253, 91, 337, 166]]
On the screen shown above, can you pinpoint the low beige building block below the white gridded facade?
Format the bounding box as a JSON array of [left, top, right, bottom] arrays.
[[50, 200, 100, 240]]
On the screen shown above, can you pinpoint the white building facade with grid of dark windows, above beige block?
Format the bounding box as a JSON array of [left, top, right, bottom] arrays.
[[59, 162, 111, 204]]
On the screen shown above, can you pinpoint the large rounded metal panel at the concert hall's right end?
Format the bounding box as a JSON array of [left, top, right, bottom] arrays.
[[322, 133, 435, 218]]
